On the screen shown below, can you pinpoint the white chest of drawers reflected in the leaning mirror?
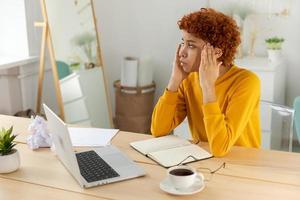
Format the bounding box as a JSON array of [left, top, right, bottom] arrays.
[[60, 67, 110, 128]]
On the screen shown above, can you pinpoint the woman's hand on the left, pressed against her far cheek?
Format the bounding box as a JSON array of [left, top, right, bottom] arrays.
[[167, 44, 188, 92]]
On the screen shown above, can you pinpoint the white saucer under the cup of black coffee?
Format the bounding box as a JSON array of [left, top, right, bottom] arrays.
[[159, 175, 205, 195]]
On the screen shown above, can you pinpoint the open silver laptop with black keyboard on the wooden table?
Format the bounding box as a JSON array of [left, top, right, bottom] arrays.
[[43, 104, 145, 188]]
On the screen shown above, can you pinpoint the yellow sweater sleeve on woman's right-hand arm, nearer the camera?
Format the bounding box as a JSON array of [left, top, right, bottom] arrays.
[[202, 75, 260, 156]]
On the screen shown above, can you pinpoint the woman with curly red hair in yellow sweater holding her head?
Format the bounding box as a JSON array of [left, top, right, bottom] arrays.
[[151, 8, 261, 156]]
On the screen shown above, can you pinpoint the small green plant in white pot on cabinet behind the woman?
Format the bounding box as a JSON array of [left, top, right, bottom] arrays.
[[265, 37, 284, 62]]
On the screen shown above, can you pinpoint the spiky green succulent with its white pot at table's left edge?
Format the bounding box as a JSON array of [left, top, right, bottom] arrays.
[[0, 127, 20, 173]]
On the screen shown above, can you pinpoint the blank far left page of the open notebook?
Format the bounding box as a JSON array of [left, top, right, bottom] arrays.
[[130, 135, 191, 155]]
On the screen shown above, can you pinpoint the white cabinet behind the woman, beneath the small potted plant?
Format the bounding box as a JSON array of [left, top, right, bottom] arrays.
[[236, 57, 286, 149]]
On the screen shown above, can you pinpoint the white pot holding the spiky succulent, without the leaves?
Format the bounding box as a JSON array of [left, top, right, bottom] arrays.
[[0, 149, 20, 173]]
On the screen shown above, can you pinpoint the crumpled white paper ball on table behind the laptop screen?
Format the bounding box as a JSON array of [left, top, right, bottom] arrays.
[[27, 115, 52, 149]]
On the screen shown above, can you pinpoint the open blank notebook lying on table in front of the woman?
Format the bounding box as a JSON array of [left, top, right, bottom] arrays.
[[130, 135, 212, 167]]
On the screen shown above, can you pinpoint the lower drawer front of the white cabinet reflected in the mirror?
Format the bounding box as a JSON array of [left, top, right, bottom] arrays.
[[64, 98, 89, 123]]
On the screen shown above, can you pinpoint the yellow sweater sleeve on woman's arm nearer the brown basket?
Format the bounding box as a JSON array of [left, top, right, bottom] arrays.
[[151, 84, 186, 137]]
